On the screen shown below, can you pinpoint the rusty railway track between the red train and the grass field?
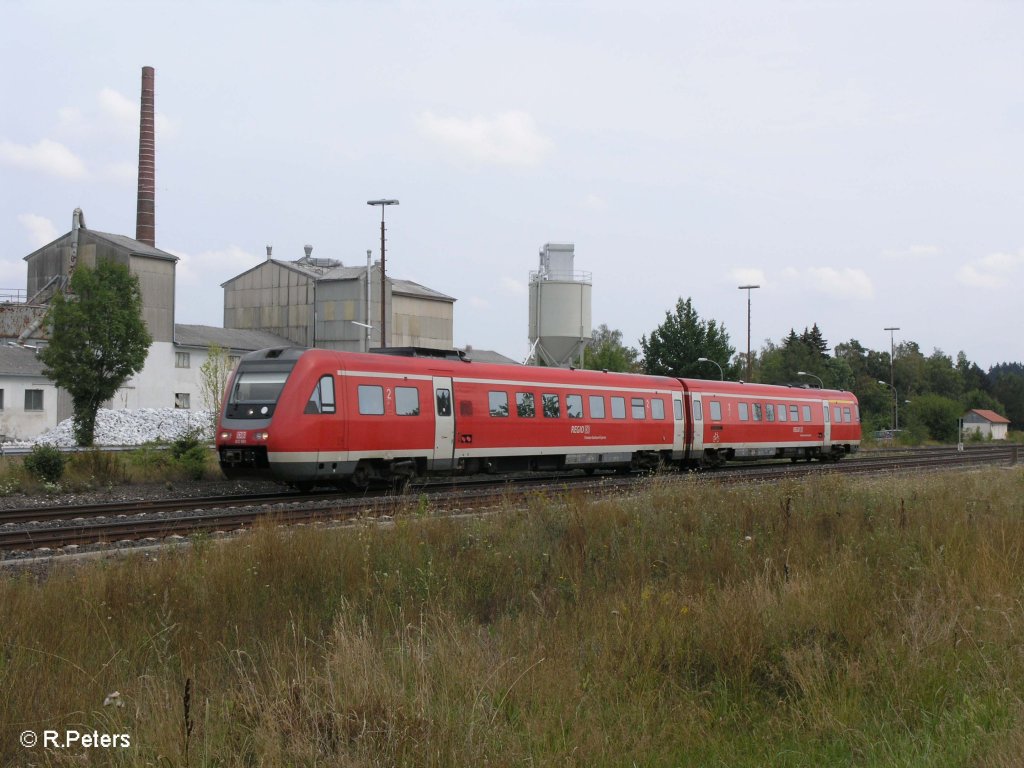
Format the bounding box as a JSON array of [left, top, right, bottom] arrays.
[[0, 445, 1018, 554]]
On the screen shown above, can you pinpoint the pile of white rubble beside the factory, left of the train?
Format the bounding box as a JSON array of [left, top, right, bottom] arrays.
[[7, 408, 213, 447]]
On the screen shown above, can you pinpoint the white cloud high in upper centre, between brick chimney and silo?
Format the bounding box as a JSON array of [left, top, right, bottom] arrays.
[[418, 111, 553, 166]]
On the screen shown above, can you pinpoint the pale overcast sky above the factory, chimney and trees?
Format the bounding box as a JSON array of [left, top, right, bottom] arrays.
[[0, 0, 1024, 369]]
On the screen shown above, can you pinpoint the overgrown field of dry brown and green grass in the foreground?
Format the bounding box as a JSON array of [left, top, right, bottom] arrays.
[[0, 468, 1024, 767]]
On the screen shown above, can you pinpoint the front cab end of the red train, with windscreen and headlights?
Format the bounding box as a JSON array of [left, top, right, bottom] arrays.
[[217, 347, 306, 480]]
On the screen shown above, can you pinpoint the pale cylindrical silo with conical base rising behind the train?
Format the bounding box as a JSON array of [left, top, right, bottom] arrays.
[[529, 243, 593, 368]]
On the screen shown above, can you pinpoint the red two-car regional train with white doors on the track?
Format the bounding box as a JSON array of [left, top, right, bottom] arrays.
[[217, 347, 860, 488]]
